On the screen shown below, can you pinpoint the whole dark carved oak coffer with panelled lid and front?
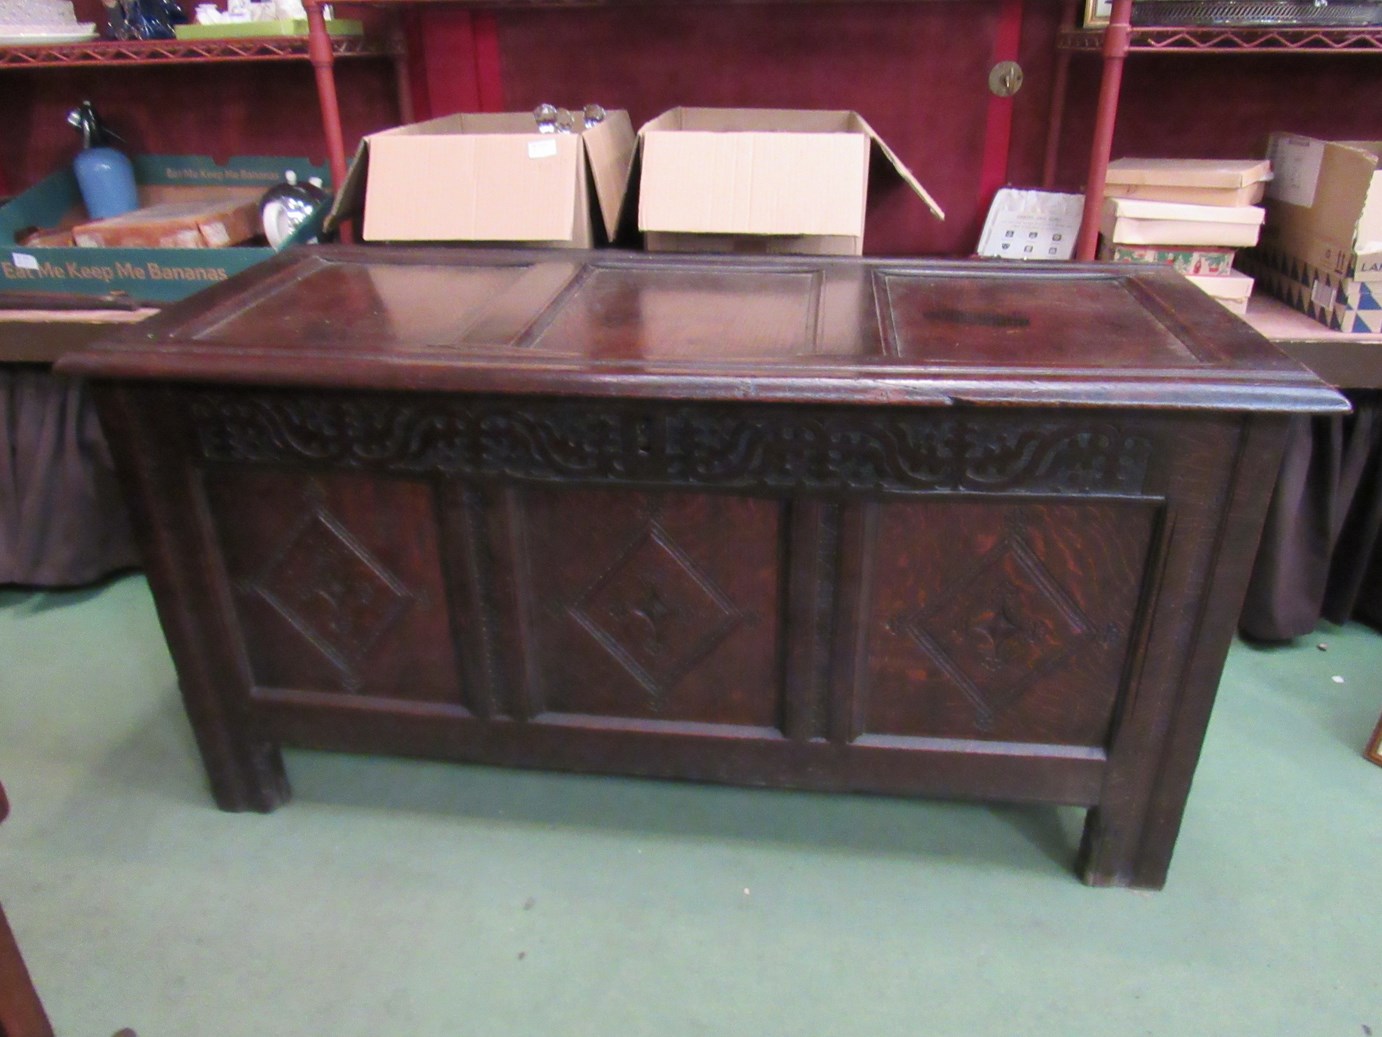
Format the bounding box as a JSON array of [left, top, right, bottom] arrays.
[[62, 249, 1345, 888]]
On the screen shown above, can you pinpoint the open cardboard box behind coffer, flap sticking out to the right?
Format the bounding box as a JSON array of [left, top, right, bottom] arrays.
[[637, 108, 945, 256]]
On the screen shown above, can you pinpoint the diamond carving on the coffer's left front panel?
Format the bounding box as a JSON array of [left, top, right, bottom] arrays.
[[246, 486, 413, 691]]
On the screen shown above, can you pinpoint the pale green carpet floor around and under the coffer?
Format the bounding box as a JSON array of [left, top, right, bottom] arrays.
[[0, 577, 1382, 1037]]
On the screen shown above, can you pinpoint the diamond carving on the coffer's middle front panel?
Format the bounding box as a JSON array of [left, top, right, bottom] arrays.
[[568, 521, 744, 709]]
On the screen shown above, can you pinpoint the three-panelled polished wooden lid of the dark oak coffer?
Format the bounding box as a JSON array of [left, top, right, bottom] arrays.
[[59, 246, 1347, 412]]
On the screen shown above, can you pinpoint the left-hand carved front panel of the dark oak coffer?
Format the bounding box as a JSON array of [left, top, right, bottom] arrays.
[[206, 469, 462, 705]]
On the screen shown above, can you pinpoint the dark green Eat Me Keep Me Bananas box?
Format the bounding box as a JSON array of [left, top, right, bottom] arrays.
[[0, 155, 329, 303]]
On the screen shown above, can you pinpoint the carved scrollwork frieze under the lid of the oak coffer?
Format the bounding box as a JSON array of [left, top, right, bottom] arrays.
[[191, 390, 1153, 495]]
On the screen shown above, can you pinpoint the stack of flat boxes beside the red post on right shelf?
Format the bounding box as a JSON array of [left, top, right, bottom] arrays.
[[1099, 159, 1271, 314]]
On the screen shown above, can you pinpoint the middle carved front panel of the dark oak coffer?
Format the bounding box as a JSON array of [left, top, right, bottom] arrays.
[[509, 489, 782, 727]]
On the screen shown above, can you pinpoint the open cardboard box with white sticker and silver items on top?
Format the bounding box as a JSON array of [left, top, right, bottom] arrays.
[[330, 111, 634, 249]]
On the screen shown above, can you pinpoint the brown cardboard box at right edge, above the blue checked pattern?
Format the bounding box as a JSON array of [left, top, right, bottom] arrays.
[[1263, 133, 1382, 283]]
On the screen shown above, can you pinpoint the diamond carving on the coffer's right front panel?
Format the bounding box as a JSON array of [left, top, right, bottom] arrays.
[[898, 534, 1095, 729]]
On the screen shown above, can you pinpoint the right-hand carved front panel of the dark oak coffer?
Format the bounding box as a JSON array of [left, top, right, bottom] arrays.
[[850, 502, 1155, 745]]
